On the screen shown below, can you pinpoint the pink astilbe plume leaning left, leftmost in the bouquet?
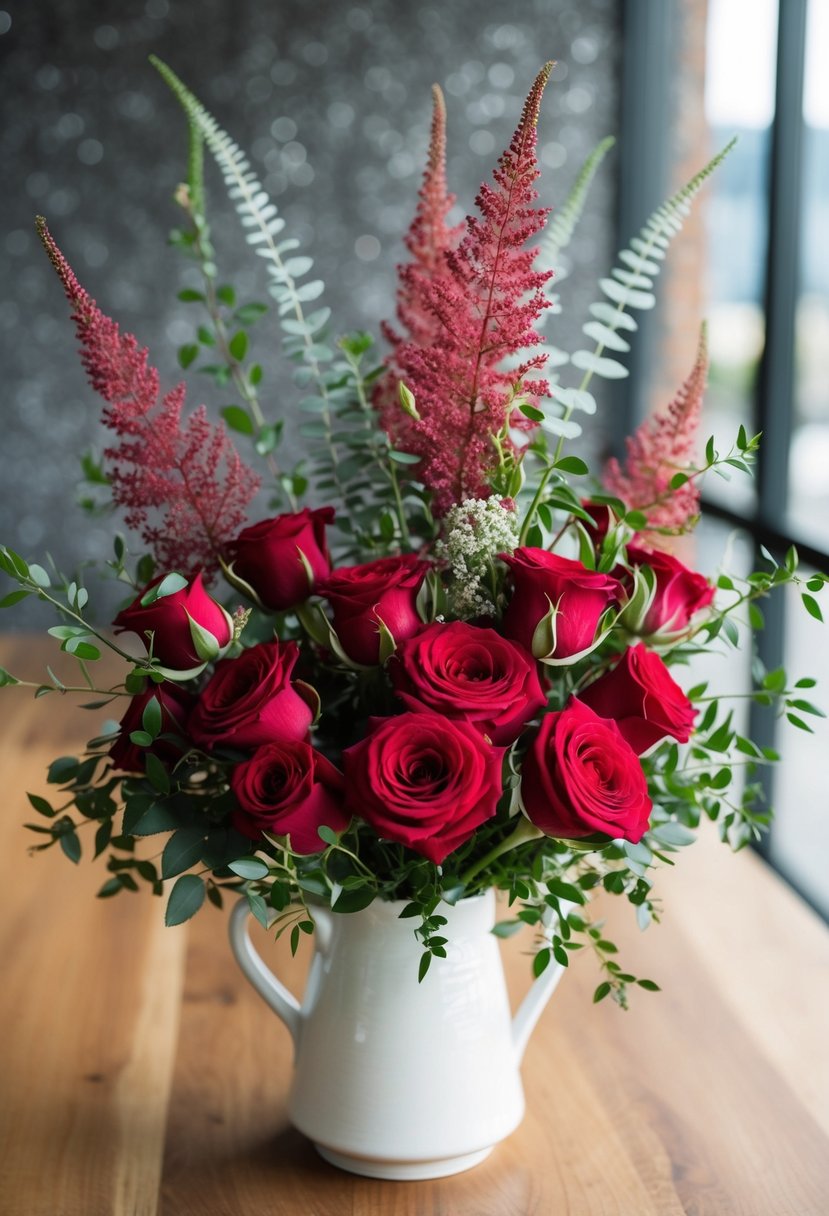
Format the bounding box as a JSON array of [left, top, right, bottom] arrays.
[[38, 218, 259, 575]]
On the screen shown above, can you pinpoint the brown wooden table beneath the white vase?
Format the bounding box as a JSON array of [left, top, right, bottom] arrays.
[[0, 638, 829, 1216]]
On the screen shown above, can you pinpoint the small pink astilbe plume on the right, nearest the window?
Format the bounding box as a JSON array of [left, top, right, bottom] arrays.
[[602, 326, 709, 552]]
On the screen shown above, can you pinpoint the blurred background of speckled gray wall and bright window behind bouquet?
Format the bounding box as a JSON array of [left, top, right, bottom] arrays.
[[0, 0, 829, 913]]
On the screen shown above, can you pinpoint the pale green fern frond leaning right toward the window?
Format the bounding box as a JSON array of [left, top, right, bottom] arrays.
[[570, 139, 737, 390]]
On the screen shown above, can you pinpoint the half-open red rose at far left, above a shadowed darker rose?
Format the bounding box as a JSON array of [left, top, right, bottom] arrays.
[[113, 574, 233, 671]]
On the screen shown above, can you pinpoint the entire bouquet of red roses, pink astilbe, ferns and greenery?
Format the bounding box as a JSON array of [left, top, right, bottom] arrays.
[[0, 61, 824, 1006]]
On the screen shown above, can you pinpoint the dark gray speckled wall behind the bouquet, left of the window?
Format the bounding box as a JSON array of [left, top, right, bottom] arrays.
[[0, 0, 619, 627]]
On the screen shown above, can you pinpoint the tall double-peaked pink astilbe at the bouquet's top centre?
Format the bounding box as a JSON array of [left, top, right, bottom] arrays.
[[376, 63, 552, 516]]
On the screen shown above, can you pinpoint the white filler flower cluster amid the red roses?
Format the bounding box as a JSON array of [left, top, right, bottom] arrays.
[[435, 497, 519, 618]]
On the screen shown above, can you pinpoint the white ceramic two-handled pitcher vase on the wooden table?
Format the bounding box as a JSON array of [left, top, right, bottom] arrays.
[[230, 891, 563, 1180]]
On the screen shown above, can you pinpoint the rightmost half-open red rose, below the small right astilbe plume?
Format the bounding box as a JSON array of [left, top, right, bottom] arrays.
[[622, 545, 714, 641]]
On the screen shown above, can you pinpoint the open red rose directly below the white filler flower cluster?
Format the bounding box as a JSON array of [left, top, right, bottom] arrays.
[[389, 620, 547, 745]]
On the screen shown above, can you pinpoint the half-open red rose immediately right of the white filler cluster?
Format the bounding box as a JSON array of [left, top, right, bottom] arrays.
[[500, 548, 621, 663]]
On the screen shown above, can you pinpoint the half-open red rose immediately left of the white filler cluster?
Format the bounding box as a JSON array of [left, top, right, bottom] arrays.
[[317, 553, 429, 666]]
